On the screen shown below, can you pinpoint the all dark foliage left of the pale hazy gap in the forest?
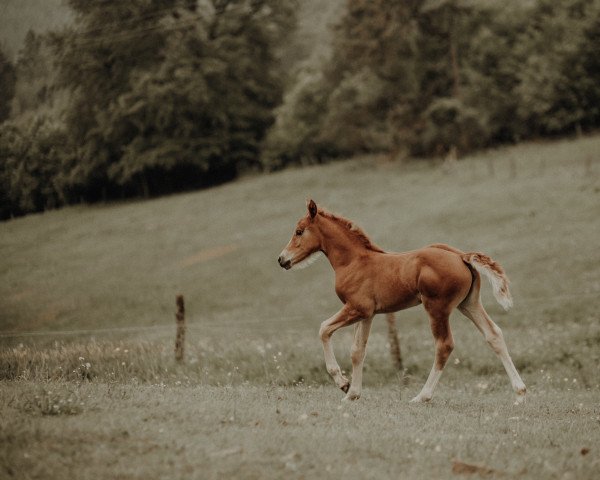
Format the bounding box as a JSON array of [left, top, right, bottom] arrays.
[[0, 0, 294, 218]]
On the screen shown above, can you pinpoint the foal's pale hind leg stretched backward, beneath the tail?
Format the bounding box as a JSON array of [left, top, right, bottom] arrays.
[[458, 294, 526, 401]]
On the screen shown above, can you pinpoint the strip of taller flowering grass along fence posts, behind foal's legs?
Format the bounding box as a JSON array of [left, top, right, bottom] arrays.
[[0, 315, 600, 393]]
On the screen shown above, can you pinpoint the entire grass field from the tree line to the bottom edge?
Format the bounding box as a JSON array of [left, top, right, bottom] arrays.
[[0, 137, 600, 479]]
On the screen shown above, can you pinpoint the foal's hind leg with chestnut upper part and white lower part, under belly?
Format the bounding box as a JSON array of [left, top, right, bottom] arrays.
[[411, 299, 454, 403]]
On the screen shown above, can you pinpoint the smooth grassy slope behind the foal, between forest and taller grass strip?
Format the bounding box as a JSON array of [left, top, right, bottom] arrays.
[[0, 137, 600, 332]]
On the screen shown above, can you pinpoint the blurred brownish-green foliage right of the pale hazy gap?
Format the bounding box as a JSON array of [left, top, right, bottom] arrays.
[[264, 0, 600, 168]]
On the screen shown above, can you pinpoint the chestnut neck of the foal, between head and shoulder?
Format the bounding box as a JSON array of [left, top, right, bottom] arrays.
[[320, 218, 368, 270]]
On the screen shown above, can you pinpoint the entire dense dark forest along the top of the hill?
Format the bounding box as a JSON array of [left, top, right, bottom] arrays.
[[0, 0, 600, 218]]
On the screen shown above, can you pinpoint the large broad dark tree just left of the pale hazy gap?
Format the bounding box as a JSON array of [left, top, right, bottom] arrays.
[[49, 0, 294, 200]]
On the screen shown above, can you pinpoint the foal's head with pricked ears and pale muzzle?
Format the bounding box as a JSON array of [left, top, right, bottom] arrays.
[[277, 200, 321, 270]]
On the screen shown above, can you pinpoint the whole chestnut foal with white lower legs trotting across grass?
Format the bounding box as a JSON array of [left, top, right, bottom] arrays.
[[278, 200, 525, 402]]
